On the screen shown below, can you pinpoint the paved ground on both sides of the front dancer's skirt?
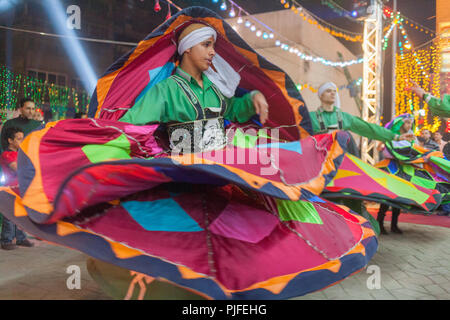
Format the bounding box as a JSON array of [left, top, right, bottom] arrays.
[[0, 218, 450, 300]]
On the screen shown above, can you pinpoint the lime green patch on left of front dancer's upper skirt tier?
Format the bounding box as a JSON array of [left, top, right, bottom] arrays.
[[81, 134, 131, 163]]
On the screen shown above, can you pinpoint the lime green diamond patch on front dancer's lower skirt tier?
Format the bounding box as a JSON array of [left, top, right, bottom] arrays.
[[277, 199, 323, 224]]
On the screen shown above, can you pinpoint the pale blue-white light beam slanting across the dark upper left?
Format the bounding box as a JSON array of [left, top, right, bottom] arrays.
[[43, 0, 97, 94]]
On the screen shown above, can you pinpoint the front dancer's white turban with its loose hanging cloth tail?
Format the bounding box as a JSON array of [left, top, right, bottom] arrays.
[[178, 26, 241, 98]]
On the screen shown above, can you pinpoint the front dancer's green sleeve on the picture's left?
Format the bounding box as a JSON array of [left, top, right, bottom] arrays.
[[119, 82, 168, 125]]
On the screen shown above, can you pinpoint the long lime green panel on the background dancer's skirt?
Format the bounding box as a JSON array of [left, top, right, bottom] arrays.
[[348, 154, 428, 204]]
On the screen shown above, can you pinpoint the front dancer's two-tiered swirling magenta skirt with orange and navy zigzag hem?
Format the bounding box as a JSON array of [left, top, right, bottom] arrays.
[[0, 119, 384, 299]]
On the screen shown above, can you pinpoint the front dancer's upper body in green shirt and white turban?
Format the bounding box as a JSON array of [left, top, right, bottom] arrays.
[[120, 23, 269, 151]]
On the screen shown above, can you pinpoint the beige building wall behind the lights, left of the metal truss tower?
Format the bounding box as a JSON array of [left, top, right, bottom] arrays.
[[227, 9, 363, 116]]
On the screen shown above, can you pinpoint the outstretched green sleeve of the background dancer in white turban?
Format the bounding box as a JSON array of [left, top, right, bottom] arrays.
[[342, 112, 396, 142]]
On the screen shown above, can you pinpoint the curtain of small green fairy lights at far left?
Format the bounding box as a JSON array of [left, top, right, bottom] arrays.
[[0, 66, 90, 120]]
